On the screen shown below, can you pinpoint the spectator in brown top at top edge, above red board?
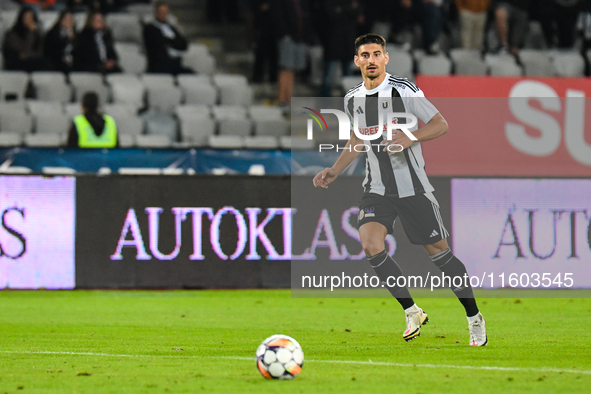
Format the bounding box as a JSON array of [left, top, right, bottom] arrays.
[[455, 0, 490, 50]]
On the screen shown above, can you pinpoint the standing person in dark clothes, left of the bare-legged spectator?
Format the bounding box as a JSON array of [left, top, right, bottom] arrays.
[[248, 0, 279, 83]]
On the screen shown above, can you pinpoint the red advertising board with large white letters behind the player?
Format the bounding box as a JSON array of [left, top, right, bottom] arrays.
[[417, 76, 591, 177]]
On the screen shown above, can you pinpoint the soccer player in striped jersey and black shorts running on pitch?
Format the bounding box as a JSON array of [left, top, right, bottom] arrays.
[[314, 34, 488, 346]]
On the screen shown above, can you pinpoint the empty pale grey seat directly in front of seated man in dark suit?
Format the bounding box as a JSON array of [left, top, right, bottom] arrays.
[[142, 74, 182, 114]]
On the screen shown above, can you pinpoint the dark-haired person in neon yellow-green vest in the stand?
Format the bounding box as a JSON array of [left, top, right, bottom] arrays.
[[68, 92, 118, 148]]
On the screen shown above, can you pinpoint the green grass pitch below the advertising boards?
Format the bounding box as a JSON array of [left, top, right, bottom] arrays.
[[0, 290, 591, 394]]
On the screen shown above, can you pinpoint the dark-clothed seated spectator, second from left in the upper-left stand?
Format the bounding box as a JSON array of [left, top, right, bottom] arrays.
[[44, 11, 76, 73]]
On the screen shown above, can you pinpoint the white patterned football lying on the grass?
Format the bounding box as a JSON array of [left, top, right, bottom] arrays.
[[257, 335, 304, 379]]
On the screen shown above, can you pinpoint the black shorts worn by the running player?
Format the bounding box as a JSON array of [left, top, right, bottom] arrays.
[[357, 193, 449, 245]]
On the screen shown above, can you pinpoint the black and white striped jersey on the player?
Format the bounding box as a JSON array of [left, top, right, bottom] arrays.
[[345, 73, 439, 198]]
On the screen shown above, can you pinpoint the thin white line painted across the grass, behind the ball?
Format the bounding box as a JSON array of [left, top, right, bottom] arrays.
[[0, 350, 591, 375]]
